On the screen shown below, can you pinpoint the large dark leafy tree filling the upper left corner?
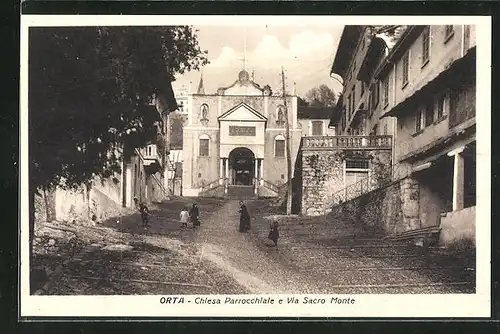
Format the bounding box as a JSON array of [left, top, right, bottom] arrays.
[[28, 26, 208, 260]]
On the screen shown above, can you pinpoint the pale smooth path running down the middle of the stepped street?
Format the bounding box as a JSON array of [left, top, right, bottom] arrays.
[[196, 201, 332, 294]]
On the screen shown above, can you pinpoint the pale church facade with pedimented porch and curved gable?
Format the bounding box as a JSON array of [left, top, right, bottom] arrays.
[[182, 70, 302, 197]]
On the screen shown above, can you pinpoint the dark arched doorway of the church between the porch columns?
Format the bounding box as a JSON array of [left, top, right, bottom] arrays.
[[229, 147, 255, 186]]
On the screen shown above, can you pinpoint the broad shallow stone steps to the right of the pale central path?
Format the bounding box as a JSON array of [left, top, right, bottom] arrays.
[[251, 208, 475, 294]]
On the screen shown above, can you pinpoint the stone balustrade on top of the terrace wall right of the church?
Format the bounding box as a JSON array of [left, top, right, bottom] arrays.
[[302, 136, 392, 149]]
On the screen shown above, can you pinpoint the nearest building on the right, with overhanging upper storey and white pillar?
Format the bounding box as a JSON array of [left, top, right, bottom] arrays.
[[379, 25, 478, 243]]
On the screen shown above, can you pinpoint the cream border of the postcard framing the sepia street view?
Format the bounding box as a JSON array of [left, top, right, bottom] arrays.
[[20, 15, 492, 318]]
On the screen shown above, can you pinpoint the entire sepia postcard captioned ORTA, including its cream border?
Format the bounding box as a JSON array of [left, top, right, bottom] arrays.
[[20, 15, 492, 318]]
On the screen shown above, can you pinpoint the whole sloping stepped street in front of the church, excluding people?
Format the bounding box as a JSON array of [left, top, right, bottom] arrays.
[[35, 199, 475, 295]]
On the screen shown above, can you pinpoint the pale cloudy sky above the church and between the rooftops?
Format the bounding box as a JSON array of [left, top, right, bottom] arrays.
[[174, 23, 343, 97]]
